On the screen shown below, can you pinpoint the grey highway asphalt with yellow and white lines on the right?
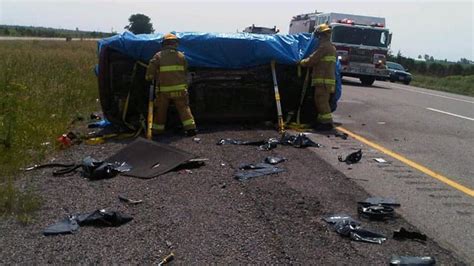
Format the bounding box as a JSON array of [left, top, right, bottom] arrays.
[[306, 78, 474, 264]]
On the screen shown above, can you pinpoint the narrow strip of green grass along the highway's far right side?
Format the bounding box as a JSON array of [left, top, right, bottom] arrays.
[[411, 74, 474, 96]]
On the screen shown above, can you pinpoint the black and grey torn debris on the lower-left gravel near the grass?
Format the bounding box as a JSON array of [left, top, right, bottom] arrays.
[[43, 210, 133, 236]]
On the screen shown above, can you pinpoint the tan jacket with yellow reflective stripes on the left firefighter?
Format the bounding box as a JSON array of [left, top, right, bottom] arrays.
[[147, 47, 188, 92]]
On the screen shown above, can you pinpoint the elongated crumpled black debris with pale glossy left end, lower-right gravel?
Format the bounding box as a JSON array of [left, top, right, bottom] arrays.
[[323, 214, 387, 244]]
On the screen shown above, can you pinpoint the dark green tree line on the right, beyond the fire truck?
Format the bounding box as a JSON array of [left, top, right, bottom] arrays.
[[388, 52, 474, 77]]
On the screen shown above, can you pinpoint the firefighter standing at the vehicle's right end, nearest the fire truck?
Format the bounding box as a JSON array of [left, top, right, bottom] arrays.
[[300, 24, 336, 130]]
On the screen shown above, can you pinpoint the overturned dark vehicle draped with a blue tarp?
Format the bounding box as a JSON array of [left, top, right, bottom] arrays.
[[96, 32, 341, 129]]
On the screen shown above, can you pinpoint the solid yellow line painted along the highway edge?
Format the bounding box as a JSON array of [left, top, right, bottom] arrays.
[[336, 127, 474, 197]]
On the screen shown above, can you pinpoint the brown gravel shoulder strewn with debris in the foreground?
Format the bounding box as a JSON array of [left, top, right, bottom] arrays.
[[0, 127, 460, 265]]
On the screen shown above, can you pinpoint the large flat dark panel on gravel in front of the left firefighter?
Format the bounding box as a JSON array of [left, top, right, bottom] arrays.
[[105, 138, 195, 179]]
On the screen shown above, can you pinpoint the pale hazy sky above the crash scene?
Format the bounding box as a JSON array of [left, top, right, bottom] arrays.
[[0, 0, 474, 61]]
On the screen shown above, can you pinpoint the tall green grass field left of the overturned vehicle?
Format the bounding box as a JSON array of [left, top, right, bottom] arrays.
[[0, 41, 99, 222]]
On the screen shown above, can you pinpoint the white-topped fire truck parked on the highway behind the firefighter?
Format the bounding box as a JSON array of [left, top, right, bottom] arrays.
[[289, 11, 392, 86]]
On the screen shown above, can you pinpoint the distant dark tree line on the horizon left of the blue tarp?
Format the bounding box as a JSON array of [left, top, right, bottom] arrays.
[[0, 25, 116, 38]]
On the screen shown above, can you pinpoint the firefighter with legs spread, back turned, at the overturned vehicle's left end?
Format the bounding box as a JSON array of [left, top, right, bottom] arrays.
[[145, 33, 196, 136]]
